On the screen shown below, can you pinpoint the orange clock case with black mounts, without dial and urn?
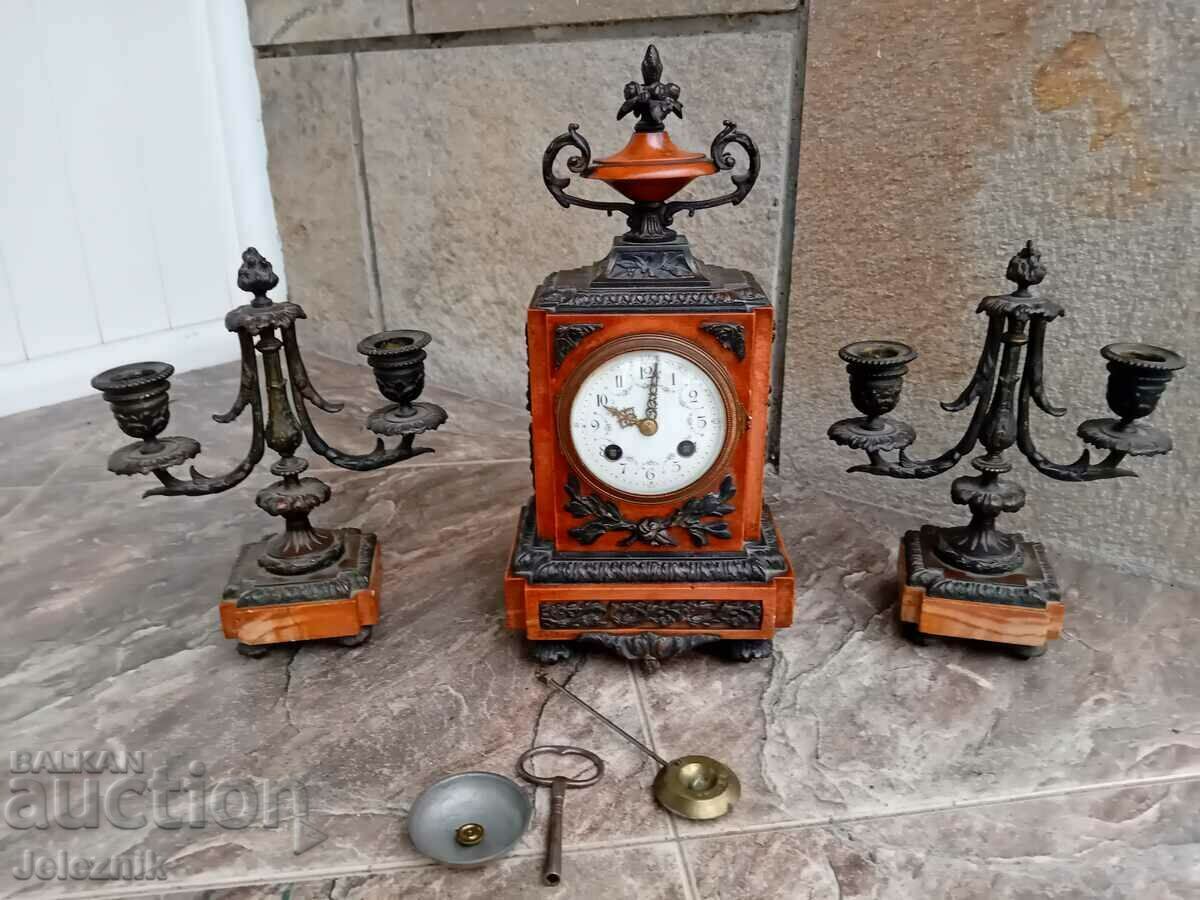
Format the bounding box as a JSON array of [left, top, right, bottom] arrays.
[[505, 254, 794, 658]]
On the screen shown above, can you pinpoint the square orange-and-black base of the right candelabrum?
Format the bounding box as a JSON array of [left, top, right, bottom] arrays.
[[898, 526, 1064, 658]]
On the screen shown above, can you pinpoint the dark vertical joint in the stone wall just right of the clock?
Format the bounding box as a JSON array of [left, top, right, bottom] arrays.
[[767, 4, 809, 473]]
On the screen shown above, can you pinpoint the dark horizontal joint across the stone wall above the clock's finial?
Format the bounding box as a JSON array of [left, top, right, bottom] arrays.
[[254, 10, 796, 59]]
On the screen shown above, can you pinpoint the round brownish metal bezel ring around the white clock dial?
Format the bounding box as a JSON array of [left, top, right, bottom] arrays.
[[554, 331, 746, 505]]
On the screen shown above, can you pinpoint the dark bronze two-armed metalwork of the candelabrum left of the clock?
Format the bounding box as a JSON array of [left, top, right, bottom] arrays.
[[91, 247, 446, 652]]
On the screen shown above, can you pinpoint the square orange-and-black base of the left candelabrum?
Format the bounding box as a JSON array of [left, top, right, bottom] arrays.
[[220, 528, 383, 656]]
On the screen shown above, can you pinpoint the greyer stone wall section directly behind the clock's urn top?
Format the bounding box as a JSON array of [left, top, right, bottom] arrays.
[[248, 0, 803, 404]]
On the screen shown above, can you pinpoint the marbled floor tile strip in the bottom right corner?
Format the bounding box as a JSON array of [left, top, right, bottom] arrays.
[[683, 782, 1200, 900]]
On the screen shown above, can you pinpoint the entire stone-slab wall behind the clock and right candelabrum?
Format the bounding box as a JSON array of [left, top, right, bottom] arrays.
[[247, 0, 1200, 583]]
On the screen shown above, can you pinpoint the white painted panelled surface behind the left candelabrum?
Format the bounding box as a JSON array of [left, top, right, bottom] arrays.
[[0, 0, 283, 415]]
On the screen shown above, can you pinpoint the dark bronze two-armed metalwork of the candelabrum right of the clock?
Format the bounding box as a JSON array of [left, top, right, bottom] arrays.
[[829, 241, 1184, 655]]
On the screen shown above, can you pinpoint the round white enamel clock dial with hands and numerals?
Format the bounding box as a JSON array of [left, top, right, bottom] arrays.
[[569, 344, 733, 498]]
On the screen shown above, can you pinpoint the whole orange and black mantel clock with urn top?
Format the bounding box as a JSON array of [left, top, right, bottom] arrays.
[[505, 46, 794, 665]]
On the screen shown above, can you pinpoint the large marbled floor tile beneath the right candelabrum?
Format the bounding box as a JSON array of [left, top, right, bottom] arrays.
[[643, 485, 1200, 834]]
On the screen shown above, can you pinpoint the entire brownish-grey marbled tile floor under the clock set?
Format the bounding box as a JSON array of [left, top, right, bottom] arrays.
[[0, 360, 1200, 900]]
